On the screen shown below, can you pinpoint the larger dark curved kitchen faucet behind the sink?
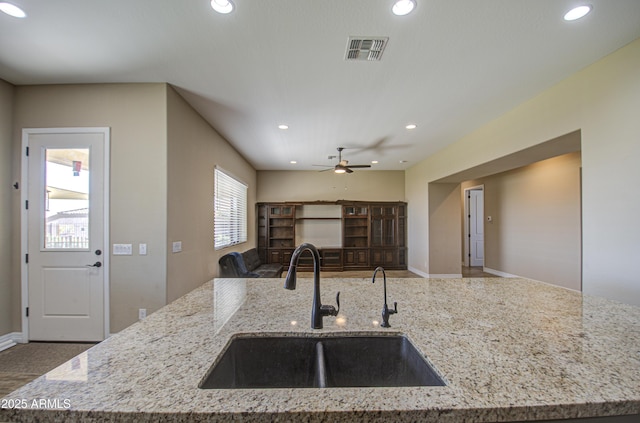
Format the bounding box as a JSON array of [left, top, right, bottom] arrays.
[[284, 242, 340, 329]]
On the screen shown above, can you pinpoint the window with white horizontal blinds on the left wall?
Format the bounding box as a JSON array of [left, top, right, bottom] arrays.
[[214, 168, 247, 249]]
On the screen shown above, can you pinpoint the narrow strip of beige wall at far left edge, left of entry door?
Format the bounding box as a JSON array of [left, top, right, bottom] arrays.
[[0, 80, 17, 336]]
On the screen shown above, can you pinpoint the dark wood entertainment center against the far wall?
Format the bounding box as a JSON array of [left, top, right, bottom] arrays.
[[256, 200, 407, 271]]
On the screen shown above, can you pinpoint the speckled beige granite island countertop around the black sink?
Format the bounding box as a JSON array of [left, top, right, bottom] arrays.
[[0, 278, 640, 422]]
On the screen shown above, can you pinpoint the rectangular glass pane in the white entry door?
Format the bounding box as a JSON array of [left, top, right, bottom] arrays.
[[43, 148, 89, 249]]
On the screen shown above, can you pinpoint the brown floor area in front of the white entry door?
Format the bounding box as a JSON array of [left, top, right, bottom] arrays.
[[0, 342, 95, 398]]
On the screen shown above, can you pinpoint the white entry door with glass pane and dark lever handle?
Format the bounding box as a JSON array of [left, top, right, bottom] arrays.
[[25, 130, 108, 341]]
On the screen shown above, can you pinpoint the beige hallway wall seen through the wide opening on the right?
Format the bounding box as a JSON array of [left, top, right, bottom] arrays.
[[461, 152, 582, 290]]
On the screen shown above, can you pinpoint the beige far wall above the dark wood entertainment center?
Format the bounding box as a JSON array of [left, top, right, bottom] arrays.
[[258, 170, 402, 204]]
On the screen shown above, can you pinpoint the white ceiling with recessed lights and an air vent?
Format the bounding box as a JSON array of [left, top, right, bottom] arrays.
[[0, 0, 640, 171]]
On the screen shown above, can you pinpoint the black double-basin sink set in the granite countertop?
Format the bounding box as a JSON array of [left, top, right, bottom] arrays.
[[199, 335, 445, 389]]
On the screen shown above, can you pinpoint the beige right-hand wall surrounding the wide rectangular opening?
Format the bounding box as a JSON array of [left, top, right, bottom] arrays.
[[405, 39, 640, 304]]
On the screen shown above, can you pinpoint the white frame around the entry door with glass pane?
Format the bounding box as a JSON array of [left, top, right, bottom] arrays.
[[19, 127, 111, 343]]
